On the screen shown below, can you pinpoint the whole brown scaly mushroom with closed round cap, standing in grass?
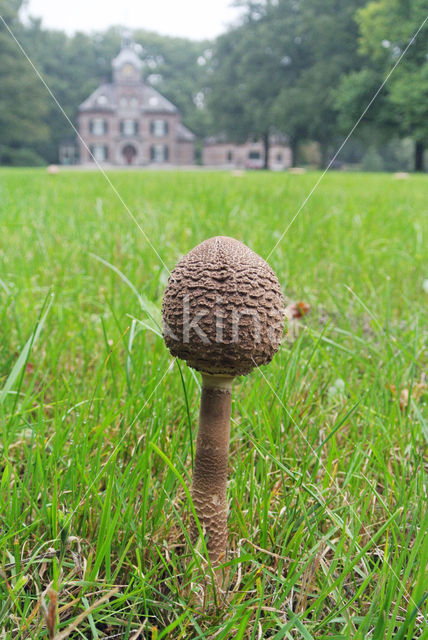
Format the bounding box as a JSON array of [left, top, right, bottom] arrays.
[[162, 236, 285, 584]]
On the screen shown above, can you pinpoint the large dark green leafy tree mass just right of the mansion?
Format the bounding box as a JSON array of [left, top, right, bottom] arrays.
[[210, 0, 366, 164]]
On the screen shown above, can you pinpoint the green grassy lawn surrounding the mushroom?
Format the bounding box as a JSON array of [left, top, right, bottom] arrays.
[[0, 170, 428, 640]]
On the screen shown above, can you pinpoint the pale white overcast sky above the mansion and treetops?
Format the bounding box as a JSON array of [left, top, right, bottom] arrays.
[[25, 0, 244, 40]]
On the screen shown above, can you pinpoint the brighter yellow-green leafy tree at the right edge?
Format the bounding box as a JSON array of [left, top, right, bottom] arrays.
[[338, 0, 428, 171]]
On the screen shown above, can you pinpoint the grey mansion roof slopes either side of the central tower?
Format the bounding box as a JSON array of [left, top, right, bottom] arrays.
[[79, 82, 179, 114]]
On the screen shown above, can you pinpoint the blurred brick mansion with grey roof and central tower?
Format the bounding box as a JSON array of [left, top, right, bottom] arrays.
[[78, 43, 195, 166]]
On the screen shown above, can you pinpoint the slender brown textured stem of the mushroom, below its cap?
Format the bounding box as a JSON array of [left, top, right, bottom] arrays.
[[191, 373, 233, 566]]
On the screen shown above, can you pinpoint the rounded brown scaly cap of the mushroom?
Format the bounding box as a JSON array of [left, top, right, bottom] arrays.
[[162, 236, 285, 377]]
